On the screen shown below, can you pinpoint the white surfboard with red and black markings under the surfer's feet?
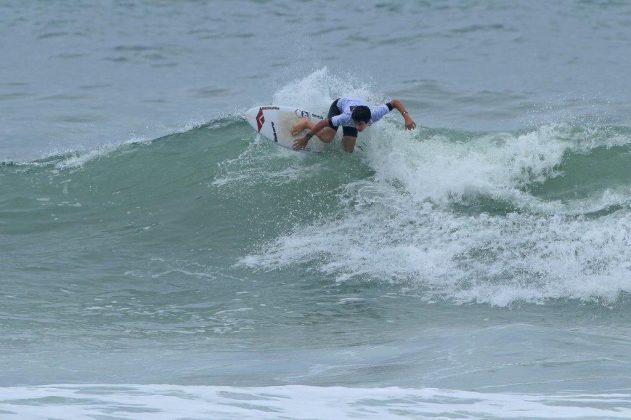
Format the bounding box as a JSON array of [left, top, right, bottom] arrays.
[[245, 105, 326, 153]]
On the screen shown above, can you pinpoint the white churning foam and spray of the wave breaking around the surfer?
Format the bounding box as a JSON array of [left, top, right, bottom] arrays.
[[240, 70, 631, 306]]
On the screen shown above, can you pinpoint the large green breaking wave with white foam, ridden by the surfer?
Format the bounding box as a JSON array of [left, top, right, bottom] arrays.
[[0, 118, 631, 305]]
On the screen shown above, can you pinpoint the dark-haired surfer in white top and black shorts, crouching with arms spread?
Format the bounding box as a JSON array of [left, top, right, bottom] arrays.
[[291, 98, 416, 153]]
